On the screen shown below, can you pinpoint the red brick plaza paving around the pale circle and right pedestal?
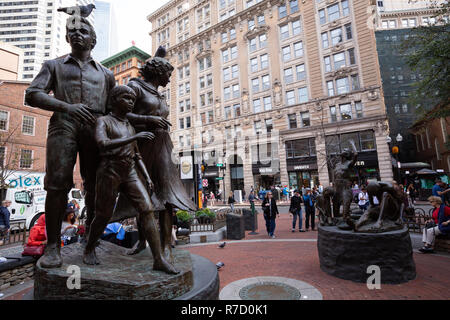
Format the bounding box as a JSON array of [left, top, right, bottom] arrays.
[[182, 213, 450, 300]]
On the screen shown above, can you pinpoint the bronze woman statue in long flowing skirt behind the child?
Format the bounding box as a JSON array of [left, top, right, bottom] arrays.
[[114, 47, 196, 254]]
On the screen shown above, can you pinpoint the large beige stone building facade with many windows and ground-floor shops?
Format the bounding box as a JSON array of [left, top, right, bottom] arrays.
[[148, 0, 392, 199]]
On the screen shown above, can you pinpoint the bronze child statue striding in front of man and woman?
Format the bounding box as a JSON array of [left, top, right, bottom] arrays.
[[83, 86, 178, 274]]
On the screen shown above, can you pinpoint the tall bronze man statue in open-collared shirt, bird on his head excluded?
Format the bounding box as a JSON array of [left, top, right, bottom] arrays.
[[26, 16, 115, 268]]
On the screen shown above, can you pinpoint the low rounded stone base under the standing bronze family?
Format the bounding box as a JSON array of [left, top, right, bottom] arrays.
[[34, 241, 219, 300]]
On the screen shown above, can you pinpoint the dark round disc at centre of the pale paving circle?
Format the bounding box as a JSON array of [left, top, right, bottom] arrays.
[[239, 281, 301, 300]]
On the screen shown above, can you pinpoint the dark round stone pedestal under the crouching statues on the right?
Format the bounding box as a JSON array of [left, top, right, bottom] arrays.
[[317, 226, 416, 284]]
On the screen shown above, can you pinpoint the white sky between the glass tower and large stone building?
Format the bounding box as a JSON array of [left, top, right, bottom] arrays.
[[102, 0, 170, 55]]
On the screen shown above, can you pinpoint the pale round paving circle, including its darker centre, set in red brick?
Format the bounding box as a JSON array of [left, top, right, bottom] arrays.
[[219, 277, 323, 300]]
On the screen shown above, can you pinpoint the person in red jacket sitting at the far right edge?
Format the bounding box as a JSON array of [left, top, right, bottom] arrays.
[[419, 196, 450, 253]]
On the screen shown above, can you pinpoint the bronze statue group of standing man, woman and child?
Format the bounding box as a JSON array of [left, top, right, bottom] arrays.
[[26, 14, 196, 274]]
